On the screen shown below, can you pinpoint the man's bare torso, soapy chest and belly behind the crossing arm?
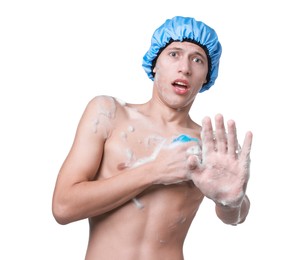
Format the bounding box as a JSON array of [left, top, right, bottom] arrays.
[[86, 96, 203, 260]]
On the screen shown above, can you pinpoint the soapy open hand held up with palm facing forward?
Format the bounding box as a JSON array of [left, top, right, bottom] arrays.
[[188, 114, 252, 207]]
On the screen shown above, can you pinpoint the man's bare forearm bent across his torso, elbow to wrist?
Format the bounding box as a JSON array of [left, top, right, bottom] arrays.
[[53, 166, 153, 224]]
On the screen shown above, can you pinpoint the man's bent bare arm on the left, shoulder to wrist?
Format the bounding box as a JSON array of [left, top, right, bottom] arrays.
[[52, 97, 152, 224]]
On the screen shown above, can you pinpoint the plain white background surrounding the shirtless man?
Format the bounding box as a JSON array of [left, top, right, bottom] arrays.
[[0, 0, 303, 260]]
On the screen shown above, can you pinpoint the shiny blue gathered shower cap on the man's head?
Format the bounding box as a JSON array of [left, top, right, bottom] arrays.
[[142, 16, 222, 93]]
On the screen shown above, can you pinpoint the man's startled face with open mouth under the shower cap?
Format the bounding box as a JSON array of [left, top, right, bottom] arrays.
[[153, 42, 208, 109]]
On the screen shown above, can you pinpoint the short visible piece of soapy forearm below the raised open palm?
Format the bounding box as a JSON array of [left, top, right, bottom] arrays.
[[216, 195, 250, 225]]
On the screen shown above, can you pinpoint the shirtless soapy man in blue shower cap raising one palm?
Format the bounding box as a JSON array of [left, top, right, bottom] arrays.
[[53, 17, 252, 260]]
